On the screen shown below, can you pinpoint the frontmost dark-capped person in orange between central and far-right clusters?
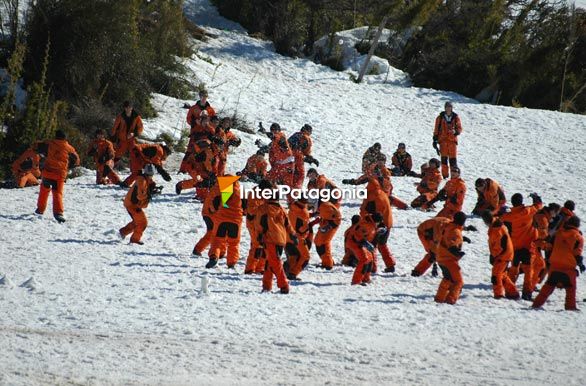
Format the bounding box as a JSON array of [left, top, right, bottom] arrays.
[[434, 212, 470, 304]]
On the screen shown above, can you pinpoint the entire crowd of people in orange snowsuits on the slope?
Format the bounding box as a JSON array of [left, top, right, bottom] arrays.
[[13, 95, 585, 310]]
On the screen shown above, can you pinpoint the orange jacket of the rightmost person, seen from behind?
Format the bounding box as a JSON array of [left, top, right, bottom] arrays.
[[549, 226, 584, 271]]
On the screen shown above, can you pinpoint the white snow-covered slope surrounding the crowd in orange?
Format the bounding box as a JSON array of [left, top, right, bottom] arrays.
[[0, 0, 586, 385]]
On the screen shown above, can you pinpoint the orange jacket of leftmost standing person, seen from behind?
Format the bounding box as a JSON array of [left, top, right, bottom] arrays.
[[34, 139, 79, 179]]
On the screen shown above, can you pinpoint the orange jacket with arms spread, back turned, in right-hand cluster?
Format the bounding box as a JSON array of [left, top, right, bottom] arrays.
[[501, 203, 543, 251]]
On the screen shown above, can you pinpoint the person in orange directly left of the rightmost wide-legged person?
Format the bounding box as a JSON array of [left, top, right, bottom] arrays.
[[533, 203, 561, 286]]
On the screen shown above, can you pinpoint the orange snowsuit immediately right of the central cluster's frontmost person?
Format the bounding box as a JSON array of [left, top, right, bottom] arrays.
[[285, 201, 313, 276]]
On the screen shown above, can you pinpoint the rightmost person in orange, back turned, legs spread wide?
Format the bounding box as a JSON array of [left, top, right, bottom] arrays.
[[532, 216, 586, 311]]
